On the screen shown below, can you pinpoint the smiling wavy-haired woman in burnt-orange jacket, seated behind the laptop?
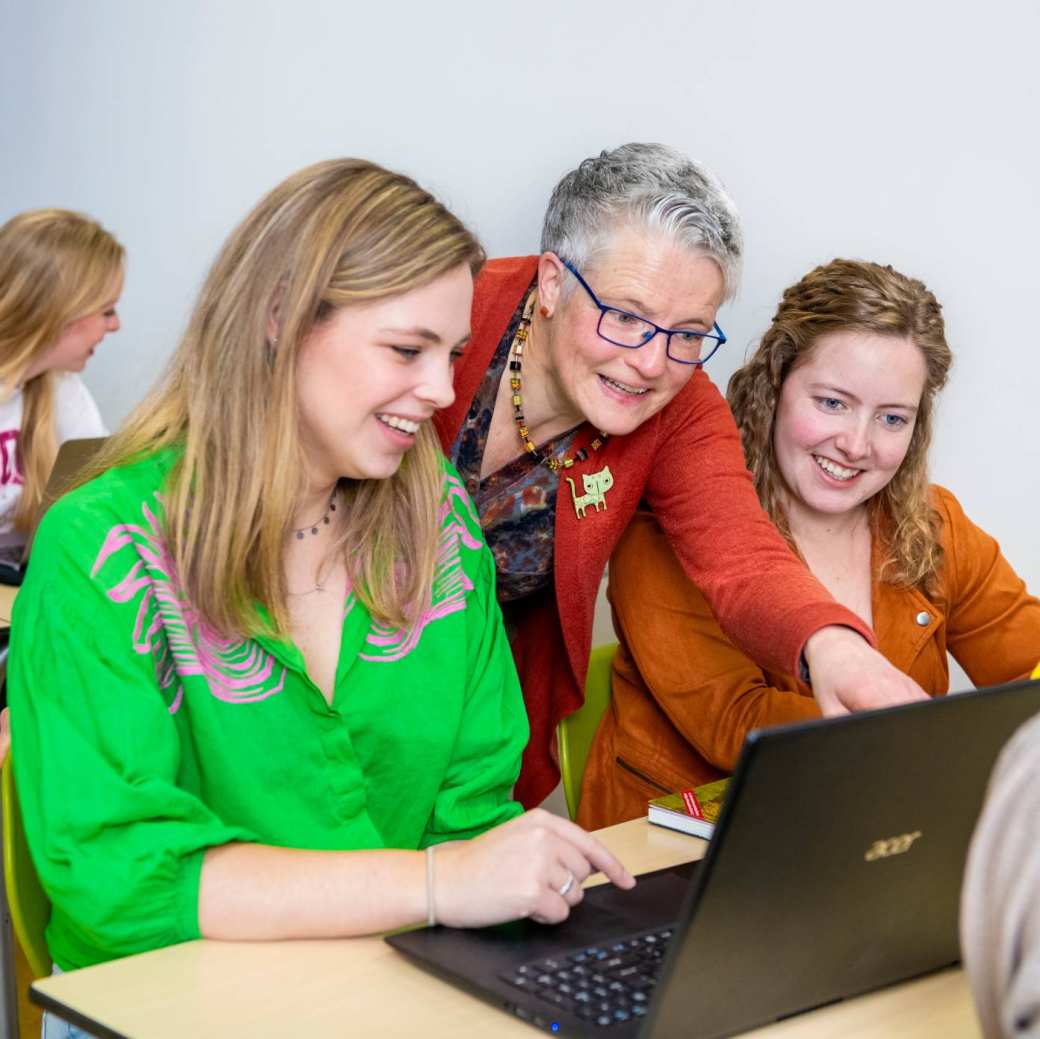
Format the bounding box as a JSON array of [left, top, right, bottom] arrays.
[[578, 260, 1040, 827]]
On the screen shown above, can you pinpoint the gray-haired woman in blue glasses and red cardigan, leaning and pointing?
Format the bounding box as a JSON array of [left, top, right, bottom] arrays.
[[436, 144, 924, 806]]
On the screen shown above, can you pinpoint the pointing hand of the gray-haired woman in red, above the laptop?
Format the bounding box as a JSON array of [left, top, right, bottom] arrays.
[[805, 625, 927, 717]]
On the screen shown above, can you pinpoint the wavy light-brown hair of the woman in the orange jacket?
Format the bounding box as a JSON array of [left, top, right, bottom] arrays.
[[727, 260, 953, 591]]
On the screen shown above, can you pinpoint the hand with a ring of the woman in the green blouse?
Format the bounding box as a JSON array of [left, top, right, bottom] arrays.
[[435, 808, 635, 927]]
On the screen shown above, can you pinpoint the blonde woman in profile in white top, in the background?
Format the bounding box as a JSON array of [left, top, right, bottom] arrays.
[[0, 209, 125, 561]]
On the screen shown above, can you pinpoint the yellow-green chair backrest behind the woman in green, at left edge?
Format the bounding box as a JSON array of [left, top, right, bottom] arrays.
[[0, 754, 51, 978]]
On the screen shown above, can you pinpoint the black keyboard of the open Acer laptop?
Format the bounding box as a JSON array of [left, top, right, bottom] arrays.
[[500, 928, 672, 1028]]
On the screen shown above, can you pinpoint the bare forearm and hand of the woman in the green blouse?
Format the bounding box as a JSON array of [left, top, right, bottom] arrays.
[[199, 809, 635, 941]]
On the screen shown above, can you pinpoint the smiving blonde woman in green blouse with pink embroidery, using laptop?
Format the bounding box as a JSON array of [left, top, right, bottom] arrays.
[[10, 153, 633, 1031]]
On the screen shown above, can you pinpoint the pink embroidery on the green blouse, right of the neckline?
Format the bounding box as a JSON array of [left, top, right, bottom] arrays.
[[352, 473, 484, 664]]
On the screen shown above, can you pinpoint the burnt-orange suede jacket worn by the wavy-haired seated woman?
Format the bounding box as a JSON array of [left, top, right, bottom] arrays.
[[578, 487, 1040, 828]]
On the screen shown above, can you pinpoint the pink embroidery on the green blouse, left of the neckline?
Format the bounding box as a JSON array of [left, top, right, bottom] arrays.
[[90, 494, 285, 715]]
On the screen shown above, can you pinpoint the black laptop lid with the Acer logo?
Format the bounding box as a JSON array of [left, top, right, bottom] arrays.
[[647, 682, 1040, 1039]]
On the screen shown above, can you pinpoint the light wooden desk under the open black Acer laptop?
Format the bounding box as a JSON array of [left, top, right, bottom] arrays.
[[32, 820, 980, 1039]]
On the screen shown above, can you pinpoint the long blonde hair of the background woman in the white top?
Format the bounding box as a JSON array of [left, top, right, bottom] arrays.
[[0, 209, 125, 531]]
